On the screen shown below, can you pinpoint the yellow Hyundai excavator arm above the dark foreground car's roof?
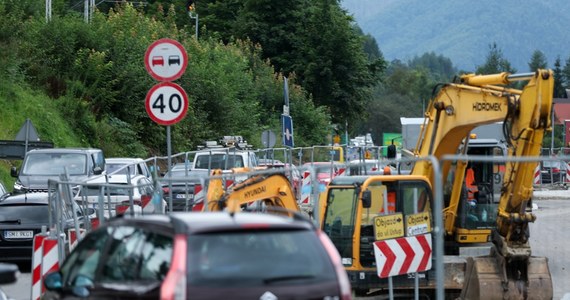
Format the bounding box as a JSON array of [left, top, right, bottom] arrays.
[[203, 168, 300, 213]]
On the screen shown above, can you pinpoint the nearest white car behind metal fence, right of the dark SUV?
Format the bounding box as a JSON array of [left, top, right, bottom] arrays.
[[75, 174, 167, 218]]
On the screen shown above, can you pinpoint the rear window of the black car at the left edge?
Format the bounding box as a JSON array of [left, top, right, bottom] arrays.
[[0, 204, 49, 224]]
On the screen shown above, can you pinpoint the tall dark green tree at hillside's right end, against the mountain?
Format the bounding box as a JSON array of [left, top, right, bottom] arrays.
[[294, 0, 381, 123]]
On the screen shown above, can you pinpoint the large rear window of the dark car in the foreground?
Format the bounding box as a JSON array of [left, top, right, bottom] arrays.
[[188, 230, 336, 287]]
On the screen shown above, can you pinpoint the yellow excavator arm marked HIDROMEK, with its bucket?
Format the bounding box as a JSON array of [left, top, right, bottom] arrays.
[[412, 70, 554, 299]]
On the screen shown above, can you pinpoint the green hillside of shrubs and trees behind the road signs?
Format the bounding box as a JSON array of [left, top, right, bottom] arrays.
[[0, 0, 570, 189]]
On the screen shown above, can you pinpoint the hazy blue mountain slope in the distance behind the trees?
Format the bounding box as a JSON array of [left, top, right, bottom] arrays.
[[341, 0, 570, 72]]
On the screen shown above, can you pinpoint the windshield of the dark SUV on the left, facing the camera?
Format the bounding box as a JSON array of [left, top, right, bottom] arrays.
[[22, 153, 87, 176]]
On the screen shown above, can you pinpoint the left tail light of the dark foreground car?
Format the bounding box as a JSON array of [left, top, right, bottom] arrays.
[[160, 234, 187, 300]]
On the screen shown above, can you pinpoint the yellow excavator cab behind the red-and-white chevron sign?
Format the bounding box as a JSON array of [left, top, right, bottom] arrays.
[[319, 175, 433, 293]]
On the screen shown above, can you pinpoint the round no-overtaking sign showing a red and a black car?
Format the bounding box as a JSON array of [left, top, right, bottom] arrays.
[[144, 39, 188, 81]]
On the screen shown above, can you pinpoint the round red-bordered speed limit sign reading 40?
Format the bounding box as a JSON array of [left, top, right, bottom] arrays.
[[145, 82, 188, 125]]
